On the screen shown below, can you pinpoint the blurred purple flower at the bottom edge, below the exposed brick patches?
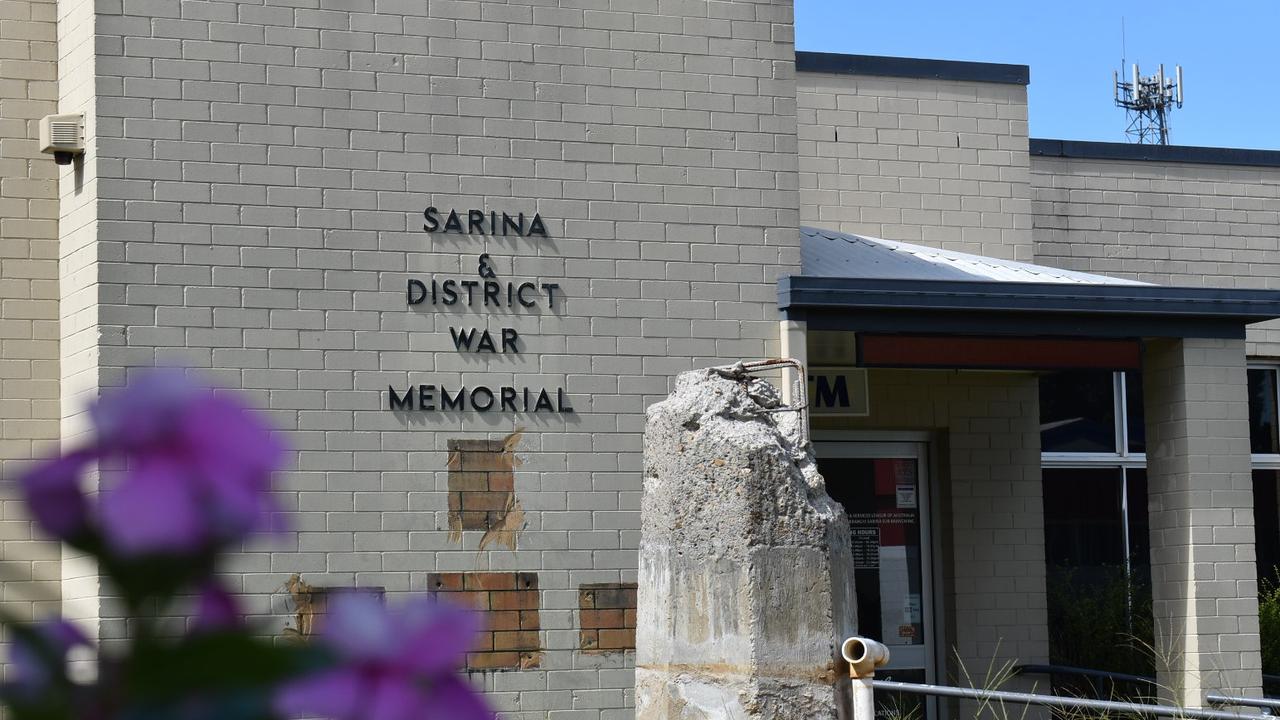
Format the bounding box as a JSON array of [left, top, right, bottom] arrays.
[[275, 593, 494, 720]]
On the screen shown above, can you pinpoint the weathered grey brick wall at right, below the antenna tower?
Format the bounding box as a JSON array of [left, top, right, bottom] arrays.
[[1032, 158, 1280, 357]]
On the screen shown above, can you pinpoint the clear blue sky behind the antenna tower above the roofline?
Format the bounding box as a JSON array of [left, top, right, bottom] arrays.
[[795, 0, 1280, 150]]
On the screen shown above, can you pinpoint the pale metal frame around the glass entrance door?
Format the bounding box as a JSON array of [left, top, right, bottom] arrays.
[[813, 430, 946, 681]]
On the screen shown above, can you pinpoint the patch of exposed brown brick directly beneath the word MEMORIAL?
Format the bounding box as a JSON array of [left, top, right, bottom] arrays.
[[449, 439, 516, 530]]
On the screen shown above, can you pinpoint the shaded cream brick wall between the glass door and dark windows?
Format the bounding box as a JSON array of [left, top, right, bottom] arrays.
[[810, 368, 1048, 684]]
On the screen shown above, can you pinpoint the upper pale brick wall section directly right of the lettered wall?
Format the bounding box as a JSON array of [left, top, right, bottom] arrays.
[[799, 73, 1032, 261]]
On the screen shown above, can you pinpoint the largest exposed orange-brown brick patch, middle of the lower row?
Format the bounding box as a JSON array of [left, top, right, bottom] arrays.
[[426, 573, 535, 670]]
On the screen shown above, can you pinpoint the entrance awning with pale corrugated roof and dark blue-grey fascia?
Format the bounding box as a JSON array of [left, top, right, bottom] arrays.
[[778, 228, 1280, 340]]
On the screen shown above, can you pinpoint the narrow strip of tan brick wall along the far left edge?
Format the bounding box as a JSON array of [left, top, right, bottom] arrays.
[[0, 0, 59, 670]]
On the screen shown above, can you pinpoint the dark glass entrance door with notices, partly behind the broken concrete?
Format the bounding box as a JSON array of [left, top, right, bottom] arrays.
[[814, 442, 936, 715]]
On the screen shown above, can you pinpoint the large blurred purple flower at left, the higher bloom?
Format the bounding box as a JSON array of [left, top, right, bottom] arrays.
[[22, 369, 283, 556]]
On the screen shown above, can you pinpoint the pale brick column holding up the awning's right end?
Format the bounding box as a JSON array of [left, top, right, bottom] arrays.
[[1143, 338, 1262, 706]]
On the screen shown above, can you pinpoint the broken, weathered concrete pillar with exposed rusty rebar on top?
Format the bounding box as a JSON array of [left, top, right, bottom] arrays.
[[636, 370, 856, 720]]
